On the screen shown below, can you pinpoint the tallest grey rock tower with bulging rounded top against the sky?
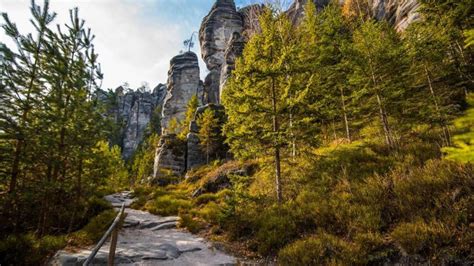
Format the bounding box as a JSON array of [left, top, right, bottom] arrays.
[[199, 0, 243, 103]]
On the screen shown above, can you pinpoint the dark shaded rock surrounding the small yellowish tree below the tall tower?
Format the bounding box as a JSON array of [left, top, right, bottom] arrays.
[[186, 103, 229, 170]]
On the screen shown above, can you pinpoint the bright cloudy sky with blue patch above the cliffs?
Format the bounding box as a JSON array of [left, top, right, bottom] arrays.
[[0, 0, 258, 89]]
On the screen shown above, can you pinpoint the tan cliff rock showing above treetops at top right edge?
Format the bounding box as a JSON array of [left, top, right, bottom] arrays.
[[286, 0, 419, 31]]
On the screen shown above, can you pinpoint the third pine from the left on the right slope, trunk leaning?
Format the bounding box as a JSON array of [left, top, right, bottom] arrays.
[[348, 20, 407, 148]]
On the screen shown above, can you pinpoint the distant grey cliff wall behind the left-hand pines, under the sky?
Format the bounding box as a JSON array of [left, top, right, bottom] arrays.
[[96, 84, 167, 159]]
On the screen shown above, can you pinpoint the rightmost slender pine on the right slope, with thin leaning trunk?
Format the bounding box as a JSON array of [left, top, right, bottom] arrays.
[[404, 22, 456, 146]]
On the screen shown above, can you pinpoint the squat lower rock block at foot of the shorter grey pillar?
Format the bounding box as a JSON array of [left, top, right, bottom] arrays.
[[154, 134, 186, 180]]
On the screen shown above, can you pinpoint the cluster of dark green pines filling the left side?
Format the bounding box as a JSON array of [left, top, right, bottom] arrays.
[[0, 1, 127, 264]]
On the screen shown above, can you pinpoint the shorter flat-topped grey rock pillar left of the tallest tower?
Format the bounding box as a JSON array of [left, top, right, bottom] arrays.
[[161, 52, 203, 134]]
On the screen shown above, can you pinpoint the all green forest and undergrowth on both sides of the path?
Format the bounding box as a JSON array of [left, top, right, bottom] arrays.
[[0, 0, 474, 265]]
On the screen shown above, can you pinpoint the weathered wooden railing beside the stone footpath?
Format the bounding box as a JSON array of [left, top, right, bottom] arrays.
[[82, 203, 125, 266]]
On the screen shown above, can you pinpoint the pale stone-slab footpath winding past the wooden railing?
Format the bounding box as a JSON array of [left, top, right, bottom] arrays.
[[49, 192, 238, 266]]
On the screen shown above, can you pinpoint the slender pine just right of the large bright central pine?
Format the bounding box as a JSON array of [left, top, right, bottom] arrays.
[[299, 2, 352, 141]]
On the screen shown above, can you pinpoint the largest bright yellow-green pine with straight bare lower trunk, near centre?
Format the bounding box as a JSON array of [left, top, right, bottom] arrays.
[[223, 9, 294, 203]]
